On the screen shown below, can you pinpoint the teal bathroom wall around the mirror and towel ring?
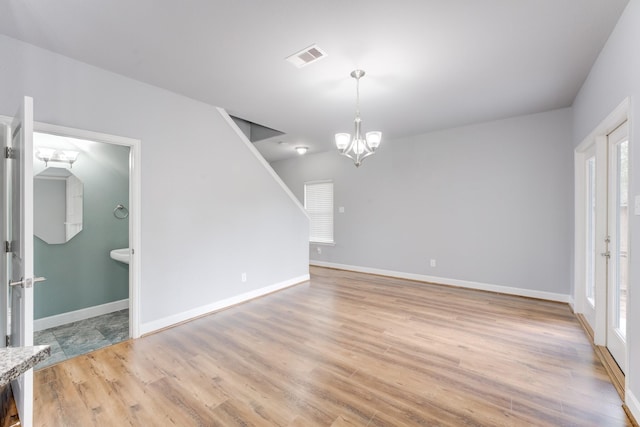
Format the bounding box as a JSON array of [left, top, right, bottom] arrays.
[[34, 136, 129, 319]]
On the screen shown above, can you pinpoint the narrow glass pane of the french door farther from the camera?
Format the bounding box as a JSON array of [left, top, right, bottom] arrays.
[[585, 156, 596, 306]]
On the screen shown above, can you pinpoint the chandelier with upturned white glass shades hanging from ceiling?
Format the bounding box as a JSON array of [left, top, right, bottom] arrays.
[[336, 70, 382, 167]]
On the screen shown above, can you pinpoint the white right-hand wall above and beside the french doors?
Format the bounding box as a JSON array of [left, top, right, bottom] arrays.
[[573, 0, 640, 420]]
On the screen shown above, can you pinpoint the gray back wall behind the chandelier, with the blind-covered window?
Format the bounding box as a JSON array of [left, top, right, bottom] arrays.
[[273, 109, 573, 295]]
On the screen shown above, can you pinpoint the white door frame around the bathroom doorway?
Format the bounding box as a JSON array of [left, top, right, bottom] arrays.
[[0, 116, 142, 338]]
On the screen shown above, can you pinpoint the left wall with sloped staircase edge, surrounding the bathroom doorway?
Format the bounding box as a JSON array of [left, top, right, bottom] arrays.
[[0, 36, 308, 331]]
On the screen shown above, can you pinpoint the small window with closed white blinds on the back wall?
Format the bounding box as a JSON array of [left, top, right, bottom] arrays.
[[304, 181, 333, 243]]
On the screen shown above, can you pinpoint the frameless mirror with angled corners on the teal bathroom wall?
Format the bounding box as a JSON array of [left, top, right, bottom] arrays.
[[33, 167, 83, 244]]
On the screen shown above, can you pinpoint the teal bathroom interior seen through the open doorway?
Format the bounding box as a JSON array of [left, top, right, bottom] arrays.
[[33, 133, 130, 369]]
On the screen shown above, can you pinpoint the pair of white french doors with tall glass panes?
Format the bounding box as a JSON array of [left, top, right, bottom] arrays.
[[576, 121, 629, 372]]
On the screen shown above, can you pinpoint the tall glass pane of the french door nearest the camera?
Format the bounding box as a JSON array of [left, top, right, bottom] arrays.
[[614, 141, 629, 337]]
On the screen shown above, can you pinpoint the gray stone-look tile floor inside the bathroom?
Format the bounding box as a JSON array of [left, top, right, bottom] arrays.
[[33, 309, 129, 370]]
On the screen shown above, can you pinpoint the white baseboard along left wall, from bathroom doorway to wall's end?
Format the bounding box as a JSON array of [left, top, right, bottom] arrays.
[[140, 274, 309, 335]]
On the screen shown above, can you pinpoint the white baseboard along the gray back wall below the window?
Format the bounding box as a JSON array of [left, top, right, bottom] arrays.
[[309, 260, 570, 303]]
